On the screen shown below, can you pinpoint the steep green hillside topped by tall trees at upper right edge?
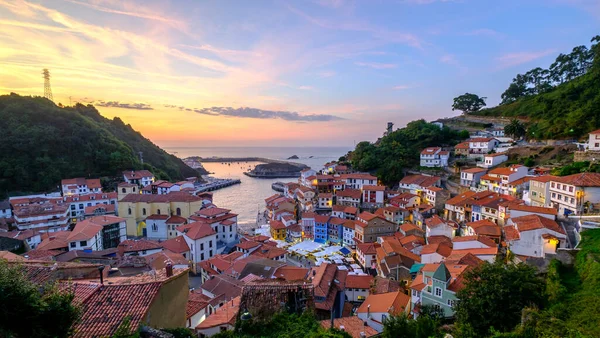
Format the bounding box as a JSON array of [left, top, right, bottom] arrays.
[[471, 37, 600, 139]]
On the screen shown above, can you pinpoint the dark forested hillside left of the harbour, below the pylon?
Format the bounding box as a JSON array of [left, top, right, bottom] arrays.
[[0, 94, 205, 196]]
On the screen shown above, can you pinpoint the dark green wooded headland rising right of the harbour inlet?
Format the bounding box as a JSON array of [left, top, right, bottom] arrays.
[[350, 120, 469, 185]]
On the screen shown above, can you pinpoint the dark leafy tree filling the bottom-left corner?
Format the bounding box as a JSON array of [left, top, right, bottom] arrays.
[[0, 259, 80, 338]]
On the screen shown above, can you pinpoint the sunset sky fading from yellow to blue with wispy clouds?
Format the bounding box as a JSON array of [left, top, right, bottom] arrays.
[[0, 0, 600, 147]]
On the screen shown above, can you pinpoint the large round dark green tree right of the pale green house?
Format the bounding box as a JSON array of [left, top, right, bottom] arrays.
[[456, 261, 545, 337]]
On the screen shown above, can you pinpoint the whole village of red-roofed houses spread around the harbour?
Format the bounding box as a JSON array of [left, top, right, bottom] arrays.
[[0, 122, 600, 337]]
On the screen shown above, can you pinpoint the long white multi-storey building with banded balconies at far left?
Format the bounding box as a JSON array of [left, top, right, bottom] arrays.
[[9, 197, 70, 232]]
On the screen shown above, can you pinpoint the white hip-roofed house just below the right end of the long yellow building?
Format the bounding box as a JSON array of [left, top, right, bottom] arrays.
[[177, 222, 218, 272]]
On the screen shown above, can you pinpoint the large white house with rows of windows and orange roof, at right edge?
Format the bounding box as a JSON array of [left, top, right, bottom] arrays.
[[549, 173, 600, 216]]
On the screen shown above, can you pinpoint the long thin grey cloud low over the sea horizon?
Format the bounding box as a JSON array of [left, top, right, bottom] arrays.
[[194, 107, 343, 122]]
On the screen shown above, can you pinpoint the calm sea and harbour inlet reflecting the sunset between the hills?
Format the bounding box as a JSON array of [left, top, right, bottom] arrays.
[[164, 147, 352, 224]]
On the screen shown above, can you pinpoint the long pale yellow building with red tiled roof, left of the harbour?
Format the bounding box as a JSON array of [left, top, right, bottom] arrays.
[[119, 191, 202, 236]]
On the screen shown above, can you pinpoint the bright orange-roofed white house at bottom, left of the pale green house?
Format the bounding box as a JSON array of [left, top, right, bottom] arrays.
[[356, 291, 410, 333]]
